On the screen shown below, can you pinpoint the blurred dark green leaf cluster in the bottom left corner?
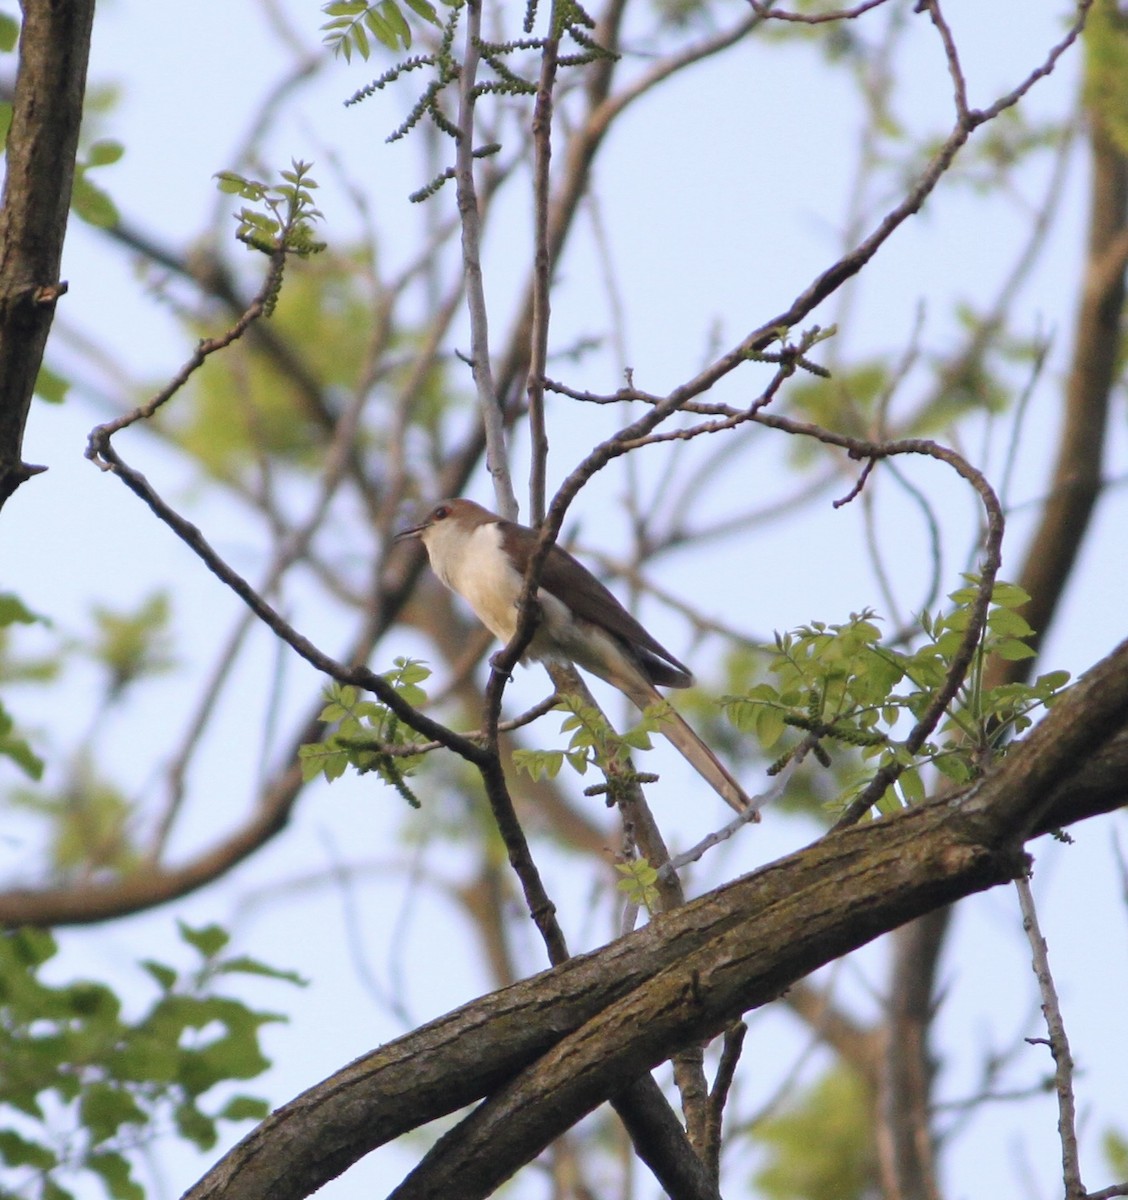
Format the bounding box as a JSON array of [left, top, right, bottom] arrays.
[[0, 923, 302, 1200]]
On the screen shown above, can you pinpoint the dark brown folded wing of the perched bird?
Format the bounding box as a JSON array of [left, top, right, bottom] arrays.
[[500, 521, 694, 688]]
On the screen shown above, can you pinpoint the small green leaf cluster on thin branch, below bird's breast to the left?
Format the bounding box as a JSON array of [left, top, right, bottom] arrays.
[[298, 658, 431, 809]]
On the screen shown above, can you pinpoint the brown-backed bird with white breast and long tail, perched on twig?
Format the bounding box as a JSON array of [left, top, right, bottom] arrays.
[[395, 498, 751, 812]]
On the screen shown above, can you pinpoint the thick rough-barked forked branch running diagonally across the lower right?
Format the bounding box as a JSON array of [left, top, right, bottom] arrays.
[[181, 643, 1128, 1200]]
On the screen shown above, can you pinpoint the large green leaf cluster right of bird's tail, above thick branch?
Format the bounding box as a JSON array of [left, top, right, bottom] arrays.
[[724, 576, 1069, 808]]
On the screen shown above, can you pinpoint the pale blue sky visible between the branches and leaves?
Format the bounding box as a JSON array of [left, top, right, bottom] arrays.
[[0, 0, 1128, 1200]]
